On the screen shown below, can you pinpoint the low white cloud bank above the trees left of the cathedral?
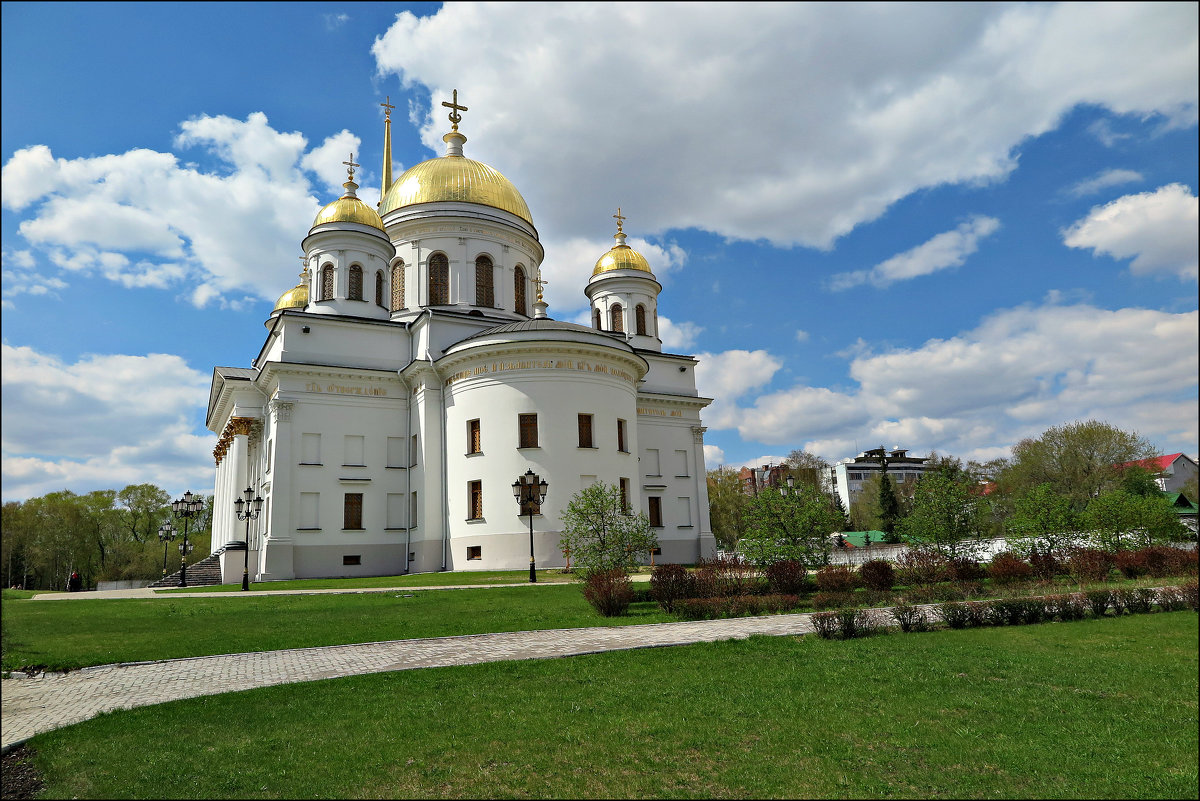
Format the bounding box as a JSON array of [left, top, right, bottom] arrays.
[[0, 344, 212, 500]]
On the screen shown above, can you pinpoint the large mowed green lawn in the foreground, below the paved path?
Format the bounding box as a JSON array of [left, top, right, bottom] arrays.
[[29, 612, 1198, 799]]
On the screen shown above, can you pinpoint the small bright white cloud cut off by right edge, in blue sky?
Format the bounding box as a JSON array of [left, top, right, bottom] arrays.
[[1062, 183, 1200, 279]]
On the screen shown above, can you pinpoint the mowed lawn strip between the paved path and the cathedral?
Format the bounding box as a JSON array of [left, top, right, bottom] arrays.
[[2, 584, 674, 670]]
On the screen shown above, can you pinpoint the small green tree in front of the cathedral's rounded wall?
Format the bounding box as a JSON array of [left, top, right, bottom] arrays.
[[558, 482, 659, 580]]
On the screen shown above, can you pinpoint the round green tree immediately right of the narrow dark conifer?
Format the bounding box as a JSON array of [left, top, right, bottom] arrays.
[[896, 472, 988, 558]]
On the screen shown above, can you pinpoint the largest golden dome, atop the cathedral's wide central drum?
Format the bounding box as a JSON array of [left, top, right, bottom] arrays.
[[379, 156, 533, 225]]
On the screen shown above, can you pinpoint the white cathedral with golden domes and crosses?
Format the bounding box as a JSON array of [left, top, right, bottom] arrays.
[[206, 92, 715, 583]]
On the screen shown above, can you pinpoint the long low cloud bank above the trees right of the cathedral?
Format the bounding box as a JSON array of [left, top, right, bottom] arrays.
[[697, 303, 1200, 458]]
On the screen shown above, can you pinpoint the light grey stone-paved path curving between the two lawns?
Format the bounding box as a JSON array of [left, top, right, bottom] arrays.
[[0, 588, 812, 747]]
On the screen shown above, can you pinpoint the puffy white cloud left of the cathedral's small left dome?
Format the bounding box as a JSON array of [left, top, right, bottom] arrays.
[[0, 113, 378, 306]]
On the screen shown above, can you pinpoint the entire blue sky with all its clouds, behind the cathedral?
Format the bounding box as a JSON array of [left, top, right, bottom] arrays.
[[0, 2, 1200, 500]]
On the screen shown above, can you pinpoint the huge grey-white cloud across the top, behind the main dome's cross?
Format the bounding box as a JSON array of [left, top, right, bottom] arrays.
[[373, 2, 1198, 248]]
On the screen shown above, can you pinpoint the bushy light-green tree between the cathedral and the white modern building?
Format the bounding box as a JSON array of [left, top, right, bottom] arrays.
[[739, 487, 842, 567]]
